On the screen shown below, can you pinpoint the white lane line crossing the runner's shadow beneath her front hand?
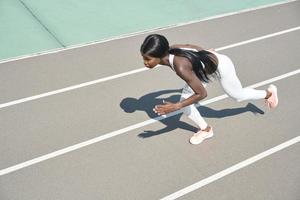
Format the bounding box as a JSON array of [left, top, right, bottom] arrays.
[[0, 69, 300, 176]]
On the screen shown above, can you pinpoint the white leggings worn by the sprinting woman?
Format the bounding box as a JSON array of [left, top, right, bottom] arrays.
[[180, 52, 267, 129]]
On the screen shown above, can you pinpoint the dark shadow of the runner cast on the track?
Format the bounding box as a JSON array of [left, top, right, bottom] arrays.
[[120, 89, 264, 138]]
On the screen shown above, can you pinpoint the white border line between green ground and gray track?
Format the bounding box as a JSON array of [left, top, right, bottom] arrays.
[[0, 0, 298, 64]]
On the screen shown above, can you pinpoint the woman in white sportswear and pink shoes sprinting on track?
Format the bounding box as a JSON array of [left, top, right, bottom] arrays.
[[140, 34, 278, 144]]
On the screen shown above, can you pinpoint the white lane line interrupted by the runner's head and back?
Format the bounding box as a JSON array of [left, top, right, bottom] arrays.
[[0, 26, 300, 109]]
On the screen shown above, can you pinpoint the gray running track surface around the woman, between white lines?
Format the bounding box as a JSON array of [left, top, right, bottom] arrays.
[[0, 1, 300, 200]]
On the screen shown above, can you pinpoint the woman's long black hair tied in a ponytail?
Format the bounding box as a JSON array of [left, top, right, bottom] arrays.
[[140, 34, 219, 83]]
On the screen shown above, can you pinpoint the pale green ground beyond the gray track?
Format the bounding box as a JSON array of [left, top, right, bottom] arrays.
[[0, 0, 288, 59]]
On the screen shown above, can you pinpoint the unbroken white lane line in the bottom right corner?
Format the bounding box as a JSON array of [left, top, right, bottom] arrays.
[[161, 136, 300, 200]]
